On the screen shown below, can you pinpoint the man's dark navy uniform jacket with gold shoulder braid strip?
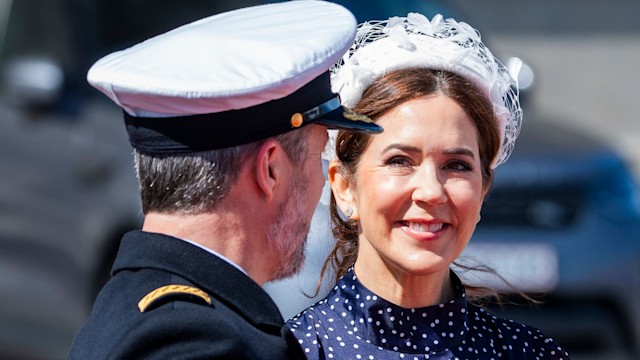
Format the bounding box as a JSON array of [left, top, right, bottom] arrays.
[[68, 231, 303, 359]]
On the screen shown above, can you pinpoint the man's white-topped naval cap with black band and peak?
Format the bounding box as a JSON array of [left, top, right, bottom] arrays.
[[87, 0, 382, 153]]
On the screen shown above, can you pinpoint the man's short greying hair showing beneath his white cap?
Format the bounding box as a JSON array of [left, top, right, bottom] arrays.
[[134, 127, 310, 215]]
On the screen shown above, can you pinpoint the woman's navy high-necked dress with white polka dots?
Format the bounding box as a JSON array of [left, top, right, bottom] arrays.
[[287, 269, 569, 360]]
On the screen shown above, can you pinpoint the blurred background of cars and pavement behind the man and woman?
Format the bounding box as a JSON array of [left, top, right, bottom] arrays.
[[0, 0, 640, 360]]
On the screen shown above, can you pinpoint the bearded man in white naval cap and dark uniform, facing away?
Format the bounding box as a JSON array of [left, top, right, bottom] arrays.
[[69, 1, 382, 359]]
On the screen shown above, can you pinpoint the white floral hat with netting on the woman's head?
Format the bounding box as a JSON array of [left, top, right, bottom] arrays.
[[331, 13, 522, 168]]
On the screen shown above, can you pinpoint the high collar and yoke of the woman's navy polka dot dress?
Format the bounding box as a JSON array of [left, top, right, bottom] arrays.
[[327, 269, 468, 353]]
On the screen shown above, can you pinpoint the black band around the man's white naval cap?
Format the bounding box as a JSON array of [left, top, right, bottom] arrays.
[[124, 72, 337, 154]]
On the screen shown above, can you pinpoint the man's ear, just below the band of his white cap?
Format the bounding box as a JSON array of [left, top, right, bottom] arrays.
[[255, 139, 287, 200]]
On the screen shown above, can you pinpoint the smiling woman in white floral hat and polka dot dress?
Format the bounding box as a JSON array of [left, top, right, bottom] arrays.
[[288, 14, 568, 359]]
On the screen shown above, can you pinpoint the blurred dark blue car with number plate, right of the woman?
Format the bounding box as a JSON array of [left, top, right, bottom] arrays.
[[469, 114, 640, 359]]
